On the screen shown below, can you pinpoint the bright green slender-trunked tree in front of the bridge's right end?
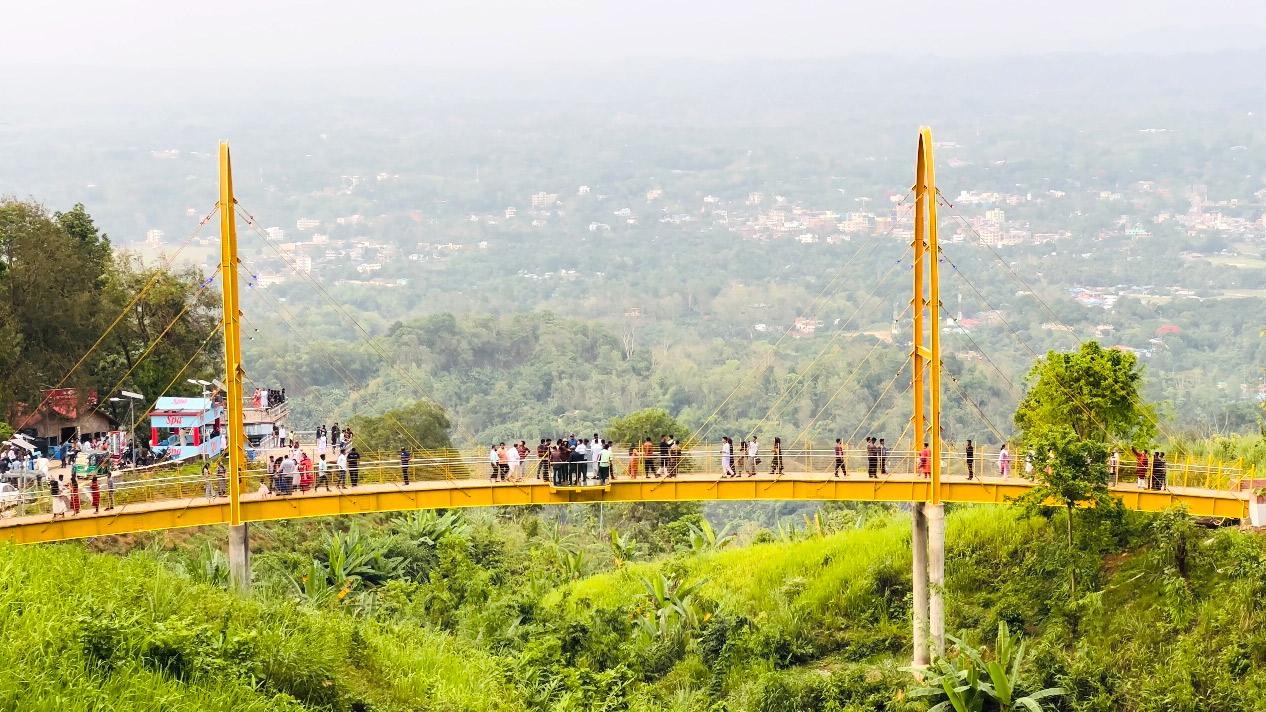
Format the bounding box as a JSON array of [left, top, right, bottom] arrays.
[[1015, 341, 1156, 597]]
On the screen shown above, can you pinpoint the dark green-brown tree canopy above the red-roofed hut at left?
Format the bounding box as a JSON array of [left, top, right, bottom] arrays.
[[0, 193, 220, 424]]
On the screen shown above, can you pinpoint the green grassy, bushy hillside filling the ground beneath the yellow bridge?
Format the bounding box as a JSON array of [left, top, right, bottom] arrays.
[[9, 505, 1266, 712]]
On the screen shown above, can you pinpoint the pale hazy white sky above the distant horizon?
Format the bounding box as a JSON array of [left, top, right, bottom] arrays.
[[7, 0, 1266, 68]]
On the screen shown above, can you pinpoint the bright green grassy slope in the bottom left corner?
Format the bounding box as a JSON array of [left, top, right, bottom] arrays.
[[0, 545, 522, 712]]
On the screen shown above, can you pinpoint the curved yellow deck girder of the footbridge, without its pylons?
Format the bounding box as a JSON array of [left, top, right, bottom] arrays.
[[0, 473, 1248, 544]]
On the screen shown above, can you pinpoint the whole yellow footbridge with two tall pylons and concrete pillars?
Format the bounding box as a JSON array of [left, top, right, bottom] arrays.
[[0, 128, 1250, 665]]
